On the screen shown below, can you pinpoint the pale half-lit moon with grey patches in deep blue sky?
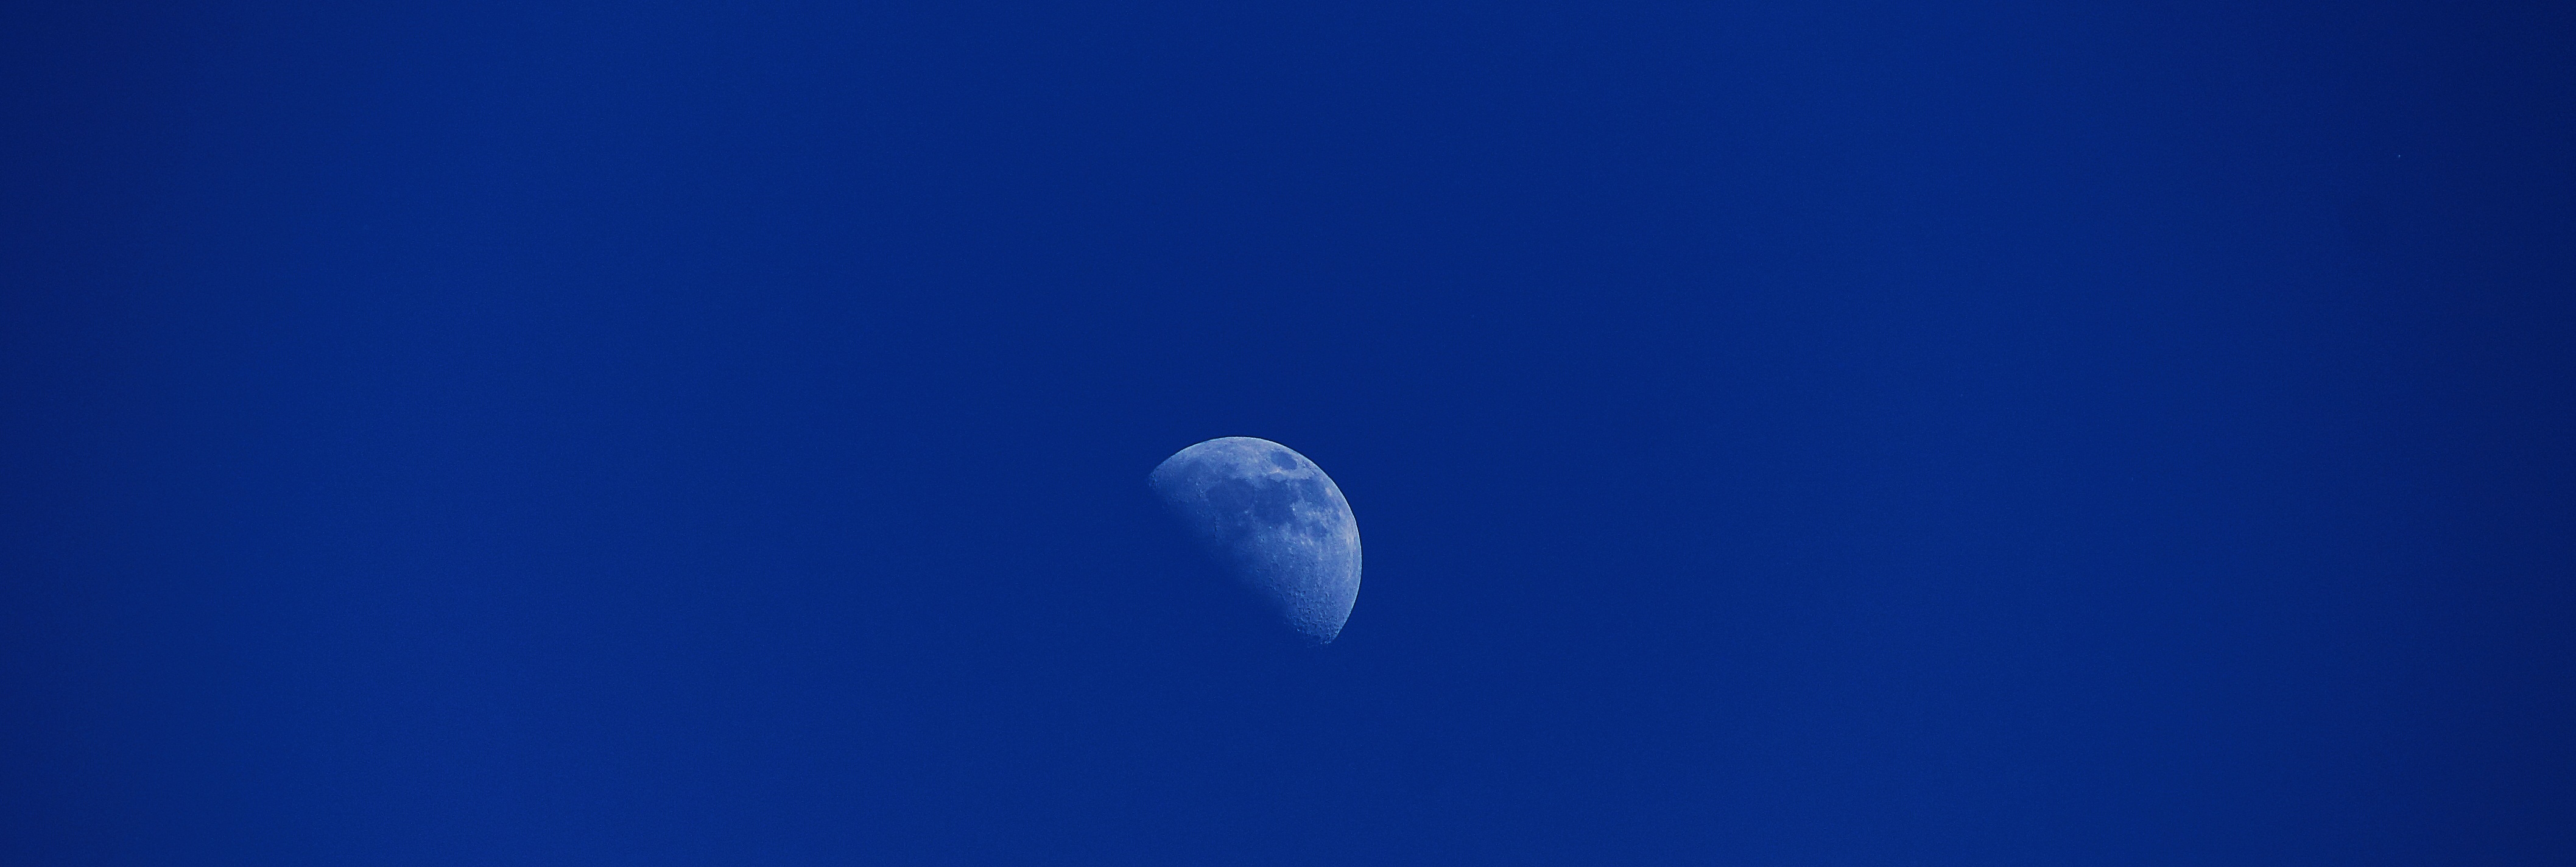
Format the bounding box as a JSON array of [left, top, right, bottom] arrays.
[[1146, 437, 1360, 643]]
